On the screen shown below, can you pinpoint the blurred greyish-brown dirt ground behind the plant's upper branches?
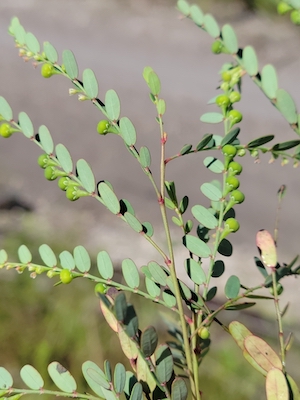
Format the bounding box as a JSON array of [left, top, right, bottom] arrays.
[[0, 0, 300, 317]]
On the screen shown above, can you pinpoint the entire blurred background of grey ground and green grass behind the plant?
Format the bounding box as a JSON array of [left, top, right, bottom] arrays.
[[0, 0, 300, 400]]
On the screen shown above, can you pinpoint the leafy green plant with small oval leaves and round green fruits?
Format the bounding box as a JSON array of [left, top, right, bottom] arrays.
[[0, 0, 300, 400]]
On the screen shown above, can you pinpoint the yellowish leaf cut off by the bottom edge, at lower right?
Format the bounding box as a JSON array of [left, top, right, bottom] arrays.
[[266, 368, 290, 400]]
